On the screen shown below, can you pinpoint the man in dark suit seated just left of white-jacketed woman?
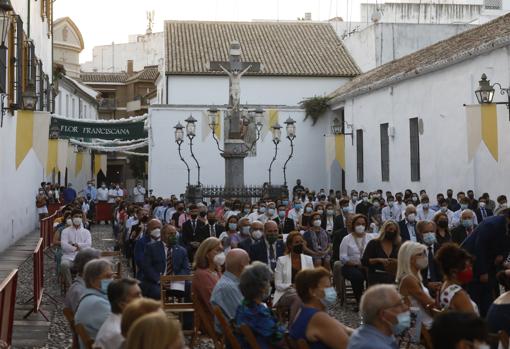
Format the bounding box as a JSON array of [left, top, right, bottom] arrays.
[[250, 221, 285, 271]]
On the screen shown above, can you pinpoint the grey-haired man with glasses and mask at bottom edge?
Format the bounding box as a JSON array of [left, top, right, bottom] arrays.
[[347, 285, 411, 349]]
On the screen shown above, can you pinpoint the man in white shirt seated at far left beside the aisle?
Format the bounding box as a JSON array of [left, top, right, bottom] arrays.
[[60, 210, 92, 286]]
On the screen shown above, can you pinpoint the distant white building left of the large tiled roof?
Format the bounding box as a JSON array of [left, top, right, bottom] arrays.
[[81, 32, 165, 72]]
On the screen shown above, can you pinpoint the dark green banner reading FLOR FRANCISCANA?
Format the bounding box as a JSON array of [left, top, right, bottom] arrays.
[[49, 118, 147, 140]]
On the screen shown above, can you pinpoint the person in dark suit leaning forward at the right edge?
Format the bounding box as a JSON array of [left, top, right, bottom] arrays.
[[461, 209, 510, 316]]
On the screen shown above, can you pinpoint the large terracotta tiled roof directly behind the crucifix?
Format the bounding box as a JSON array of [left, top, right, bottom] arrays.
[[165, 21, 359, 77]]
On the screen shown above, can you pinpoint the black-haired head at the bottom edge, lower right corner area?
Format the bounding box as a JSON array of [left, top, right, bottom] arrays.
[[430, 311, 489, 349]]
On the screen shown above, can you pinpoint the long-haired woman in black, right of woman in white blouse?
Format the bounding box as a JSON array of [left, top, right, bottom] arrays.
[[361, 220, 401, 285]]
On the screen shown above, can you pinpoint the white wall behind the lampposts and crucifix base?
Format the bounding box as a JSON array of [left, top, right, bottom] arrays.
[[149, 105, 328, 197]]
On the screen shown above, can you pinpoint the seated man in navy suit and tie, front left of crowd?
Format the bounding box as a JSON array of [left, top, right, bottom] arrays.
[[142, 224, 191, 300]]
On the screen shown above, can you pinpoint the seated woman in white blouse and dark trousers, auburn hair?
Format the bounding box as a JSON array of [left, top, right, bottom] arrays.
[[340, 214, 373, 311]]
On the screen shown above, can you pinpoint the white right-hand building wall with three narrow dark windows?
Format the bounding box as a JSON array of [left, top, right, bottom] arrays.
[[338, 47, 510, 197]]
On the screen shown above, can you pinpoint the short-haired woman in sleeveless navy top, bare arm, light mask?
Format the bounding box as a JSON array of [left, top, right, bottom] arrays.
[[289, 267, 352, 349]]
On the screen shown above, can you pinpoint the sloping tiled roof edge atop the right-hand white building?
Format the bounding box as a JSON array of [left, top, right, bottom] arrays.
[[330, 14, 510, 104]]
